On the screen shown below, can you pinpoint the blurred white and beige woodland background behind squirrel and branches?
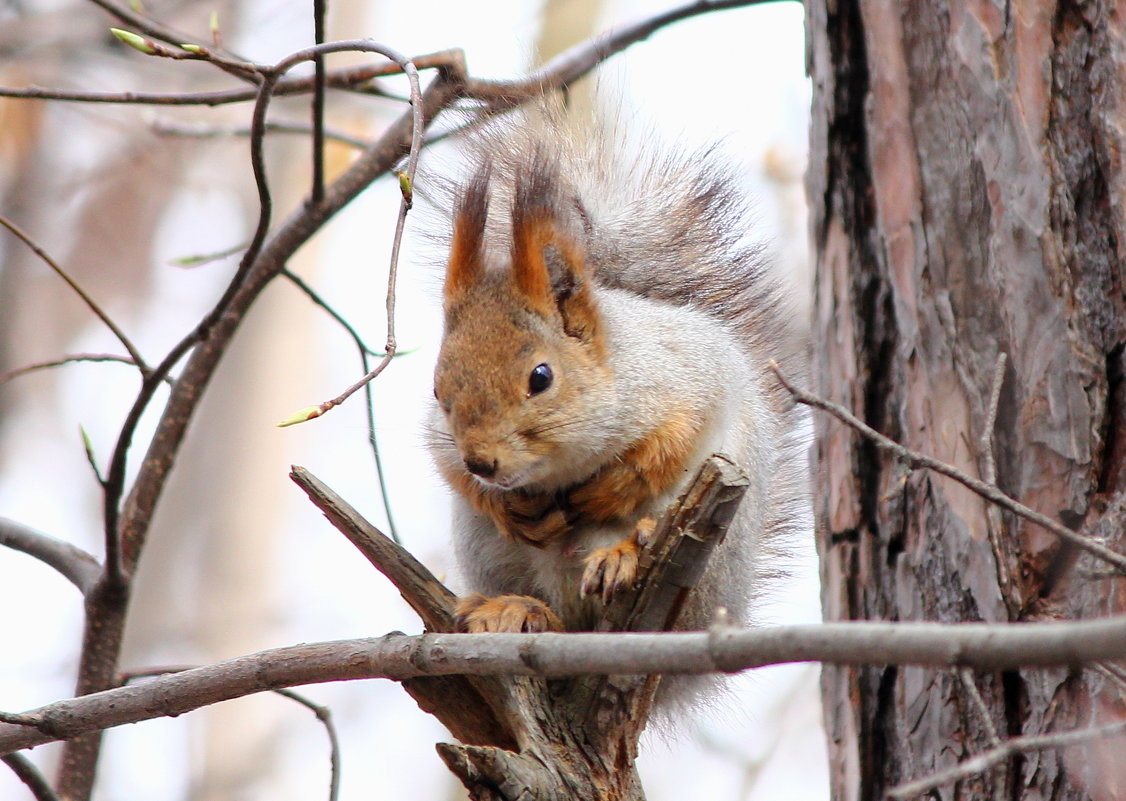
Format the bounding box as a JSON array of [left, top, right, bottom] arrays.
[[0, 0, 828, 801]]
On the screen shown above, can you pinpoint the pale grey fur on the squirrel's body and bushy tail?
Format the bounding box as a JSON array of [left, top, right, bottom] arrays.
[[431, 105, 808, 712]]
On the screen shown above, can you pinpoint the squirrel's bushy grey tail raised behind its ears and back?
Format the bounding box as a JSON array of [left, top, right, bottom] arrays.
[[425, 99, 796, 362]]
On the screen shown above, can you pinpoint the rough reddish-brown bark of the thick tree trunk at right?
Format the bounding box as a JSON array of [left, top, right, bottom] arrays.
[[806, 0, 1126, 799]]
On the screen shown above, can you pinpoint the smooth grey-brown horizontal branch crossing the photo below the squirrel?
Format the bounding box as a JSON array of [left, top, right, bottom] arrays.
[[0, 615, 1126, 754]]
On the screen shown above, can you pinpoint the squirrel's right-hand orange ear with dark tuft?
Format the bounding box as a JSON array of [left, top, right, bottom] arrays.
[[512, 155, 598, 340]]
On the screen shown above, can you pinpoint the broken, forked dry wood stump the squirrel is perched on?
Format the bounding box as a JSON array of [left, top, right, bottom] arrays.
[[292, 455, 747, 801]]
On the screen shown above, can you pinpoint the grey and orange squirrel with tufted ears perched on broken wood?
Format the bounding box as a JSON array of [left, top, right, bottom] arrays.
[[430, 104, 808, 689]]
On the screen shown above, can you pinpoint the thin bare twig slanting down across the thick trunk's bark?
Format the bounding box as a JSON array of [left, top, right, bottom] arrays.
[[770, 363, 1126, 572]]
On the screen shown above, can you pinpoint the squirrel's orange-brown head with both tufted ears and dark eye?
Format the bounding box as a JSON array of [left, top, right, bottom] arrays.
[[435, 159, 610, 490]]
